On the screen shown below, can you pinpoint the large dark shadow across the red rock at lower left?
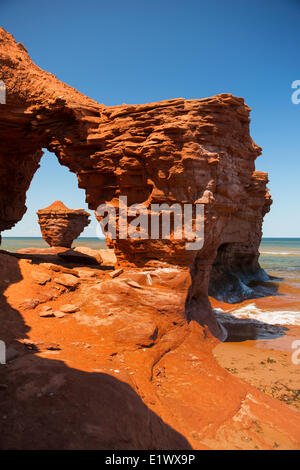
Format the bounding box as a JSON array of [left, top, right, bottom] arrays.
[[0, 254, 191, 450]]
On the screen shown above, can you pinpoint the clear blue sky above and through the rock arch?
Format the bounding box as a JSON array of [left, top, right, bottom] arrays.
[[0, 0, 300, 237]]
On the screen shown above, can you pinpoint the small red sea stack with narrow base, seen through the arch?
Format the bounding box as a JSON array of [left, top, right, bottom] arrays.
[[37, 201, 90, 248]]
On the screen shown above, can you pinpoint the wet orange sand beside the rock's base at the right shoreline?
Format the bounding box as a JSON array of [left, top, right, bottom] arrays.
[[211, 266, 300, 409]]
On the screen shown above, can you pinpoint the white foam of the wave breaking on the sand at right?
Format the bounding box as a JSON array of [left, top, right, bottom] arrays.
[[215, 304, 300, 326]]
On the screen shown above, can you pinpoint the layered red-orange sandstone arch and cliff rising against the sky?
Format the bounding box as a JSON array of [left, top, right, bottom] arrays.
[[0, 29, 271, 337]]
